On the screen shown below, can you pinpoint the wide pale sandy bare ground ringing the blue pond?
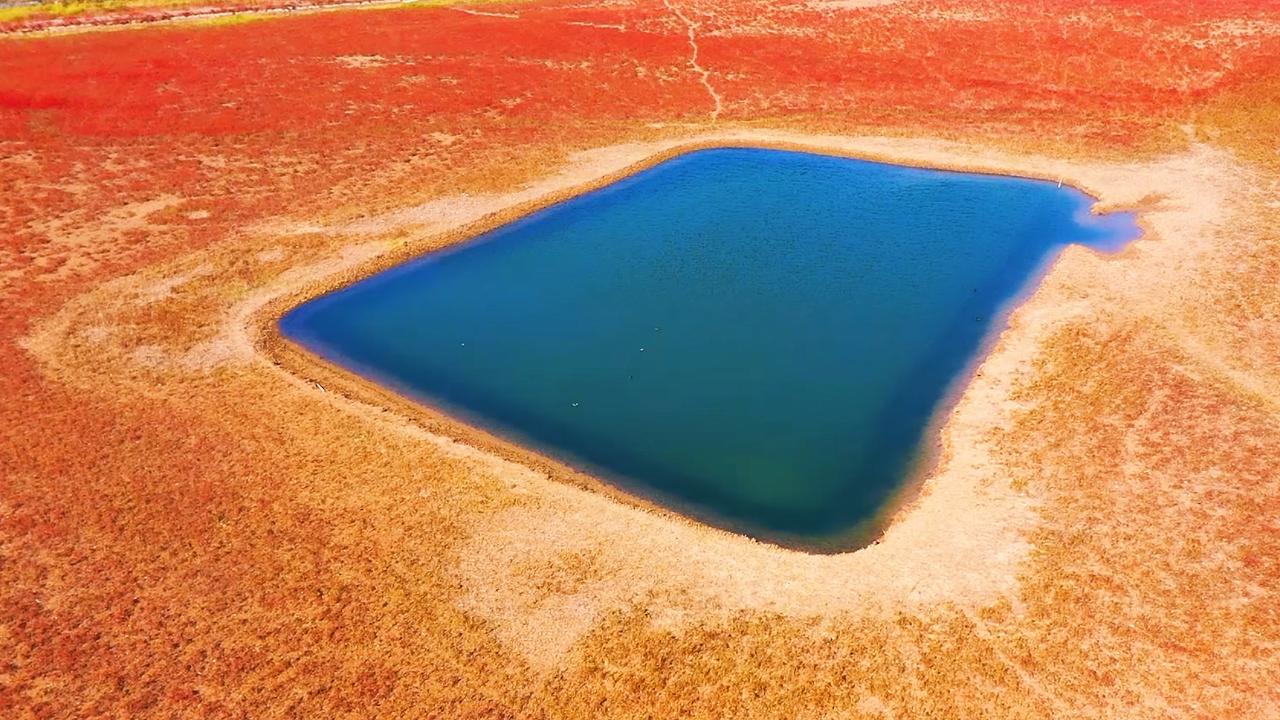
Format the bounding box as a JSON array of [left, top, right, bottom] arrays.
[[27, 131, 1249, 670]]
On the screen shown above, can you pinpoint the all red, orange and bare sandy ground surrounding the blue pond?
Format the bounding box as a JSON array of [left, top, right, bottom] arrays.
[[0, 0, 1280, 717]]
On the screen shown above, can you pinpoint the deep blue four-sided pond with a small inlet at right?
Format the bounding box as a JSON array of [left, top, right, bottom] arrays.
[[280, 149, 1139, 551]]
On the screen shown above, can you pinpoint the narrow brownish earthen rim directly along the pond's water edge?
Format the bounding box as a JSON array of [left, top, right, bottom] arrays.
[[250, 132, 1147, 555]]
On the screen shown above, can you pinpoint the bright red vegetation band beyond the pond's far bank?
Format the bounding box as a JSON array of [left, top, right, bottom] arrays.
[[0, 0, 1280, 304]]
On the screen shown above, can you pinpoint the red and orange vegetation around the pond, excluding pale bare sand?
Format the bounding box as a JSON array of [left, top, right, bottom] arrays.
[[0, 0, 1280, 717]]
